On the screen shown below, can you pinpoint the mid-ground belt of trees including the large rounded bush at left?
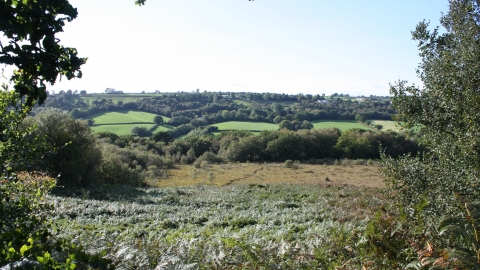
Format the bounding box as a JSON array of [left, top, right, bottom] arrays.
[[21, 109, 423, 187]]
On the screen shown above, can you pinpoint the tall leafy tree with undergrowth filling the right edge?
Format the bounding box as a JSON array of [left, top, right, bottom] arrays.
[[371, 0, 480, 269]]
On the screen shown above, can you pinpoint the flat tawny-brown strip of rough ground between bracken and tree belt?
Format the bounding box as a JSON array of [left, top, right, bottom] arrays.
[[149, 163, 384, 188]]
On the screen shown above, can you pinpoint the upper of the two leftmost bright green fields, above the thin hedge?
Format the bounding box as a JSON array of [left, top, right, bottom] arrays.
[[88, 111, 170, 125]]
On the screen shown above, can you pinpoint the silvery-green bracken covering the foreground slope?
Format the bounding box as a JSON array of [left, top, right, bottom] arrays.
[[50, 161, 382, 269]]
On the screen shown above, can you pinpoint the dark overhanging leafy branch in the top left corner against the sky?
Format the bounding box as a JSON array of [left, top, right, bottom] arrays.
[[0, 0, 87, 105]]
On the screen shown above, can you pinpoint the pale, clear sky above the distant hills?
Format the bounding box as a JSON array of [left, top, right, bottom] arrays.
[[42, 0, 448, 96]]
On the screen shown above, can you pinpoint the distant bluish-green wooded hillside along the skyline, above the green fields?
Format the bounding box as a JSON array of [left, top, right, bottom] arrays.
[[41, 92, 395, 130]]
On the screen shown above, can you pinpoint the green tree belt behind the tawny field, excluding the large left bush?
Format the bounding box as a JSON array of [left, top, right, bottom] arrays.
[[98, 128, 423, 164]]
